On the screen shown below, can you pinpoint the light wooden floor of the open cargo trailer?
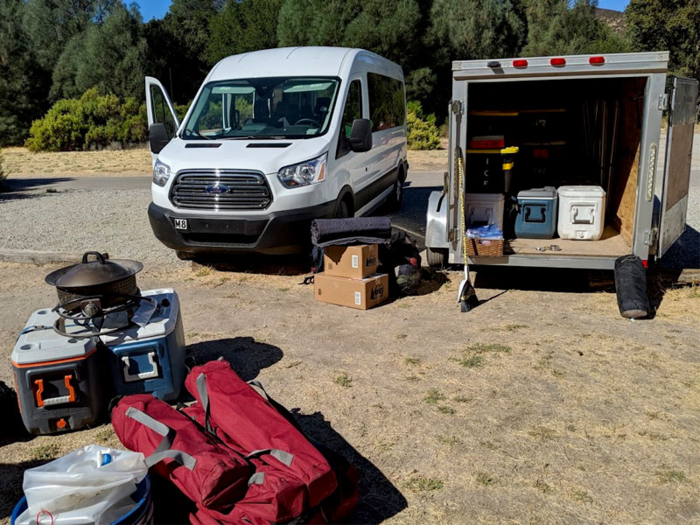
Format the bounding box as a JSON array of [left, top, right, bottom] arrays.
[[505, 226, 632, 257]]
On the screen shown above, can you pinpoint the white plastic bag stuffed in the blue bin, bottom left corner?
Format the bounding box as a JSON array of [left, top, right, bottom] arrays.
[[16, 445, 148, 525]]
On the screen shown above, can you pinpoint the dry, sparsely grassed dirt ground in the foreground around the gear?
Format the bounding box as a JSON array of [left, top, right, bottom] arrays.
[[0, 264, 700, 524]]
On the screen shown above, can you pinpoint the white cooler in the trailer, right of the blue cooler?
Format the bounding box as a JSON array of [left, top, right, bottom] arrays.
[[557, 186, 605, 241]]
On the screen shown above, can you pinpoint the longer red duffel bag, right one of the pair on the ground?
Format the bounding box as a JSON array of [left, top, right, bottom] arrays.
[[185, 361, 338, 508]]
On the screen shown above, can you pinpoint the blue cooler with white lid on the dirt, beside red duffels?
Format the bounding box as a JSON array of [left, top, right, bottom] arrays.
[[100, 289, 186, 401]]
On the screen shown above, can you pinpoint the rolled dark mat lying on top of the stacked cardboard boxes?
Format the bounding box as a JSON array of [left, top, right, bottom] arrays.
[[311, 217, 391, 248]]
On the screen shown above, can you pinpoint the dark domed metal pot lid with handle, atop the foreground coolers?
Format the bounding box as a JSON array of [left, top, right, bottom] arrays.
[[45, 252, 143, 288]]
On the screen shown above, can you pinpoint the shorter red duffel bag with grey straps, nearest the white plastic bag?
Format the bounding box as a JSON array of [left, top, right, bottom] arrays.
[[112, 394, 254, 512]]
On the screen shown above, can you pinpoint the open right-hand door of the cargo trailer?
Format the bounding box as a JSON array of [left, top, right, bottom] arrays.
[[656, 78, 698, 257]]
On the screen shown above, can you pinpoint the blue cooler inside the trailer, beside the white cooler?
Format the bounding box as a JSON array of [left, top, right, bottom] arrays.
[[515, 186, 559, 239]]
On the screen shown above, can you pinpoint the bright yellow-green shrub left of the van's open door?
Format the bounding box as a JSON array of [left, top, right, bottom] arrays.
[[26, 88, 147, 151]]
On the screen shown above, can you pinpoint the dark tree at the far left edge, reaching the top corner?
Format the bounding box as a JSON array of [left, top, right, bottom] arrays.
[[0, 0, 48, 146]]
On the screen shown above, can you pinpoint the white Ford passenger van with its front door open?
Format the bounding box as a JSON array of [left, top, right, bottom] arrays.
[[146, 47, 408, 258]]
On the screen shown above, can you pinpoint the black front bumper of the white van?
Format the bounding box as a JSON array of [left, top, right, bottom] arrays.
[[148, 201, 336, 255]]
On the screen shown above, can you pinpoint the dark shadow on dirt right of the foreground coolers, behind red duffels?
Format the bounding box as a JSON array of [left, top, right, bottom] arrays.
[[187, 337, 284, 381]]
